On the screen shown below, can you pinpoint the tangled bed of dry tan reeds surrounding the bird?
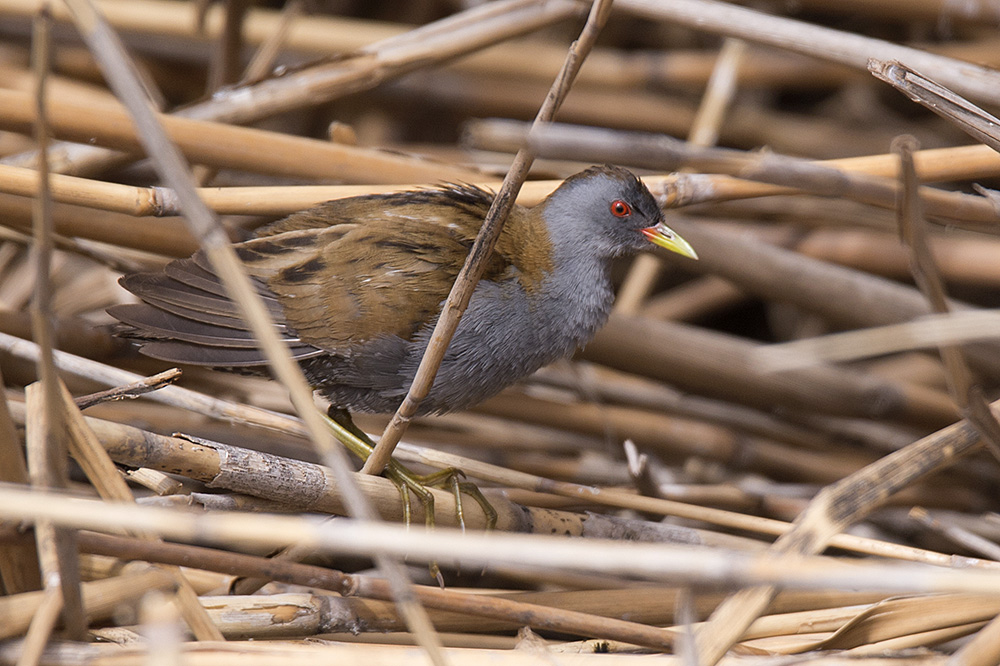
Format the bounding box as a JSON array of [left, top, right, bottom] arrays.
[[0, 0, 1000, 665]]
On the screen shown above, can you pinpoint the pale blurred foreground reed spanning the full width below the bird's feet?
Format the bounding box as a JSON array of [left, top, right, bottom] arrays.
[[0, 480, 1000, 595]]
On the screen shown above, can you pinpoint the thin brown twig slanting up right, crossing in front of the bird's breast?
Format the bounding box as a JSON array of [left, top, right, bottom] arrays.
[[362, 0, 612, 474]]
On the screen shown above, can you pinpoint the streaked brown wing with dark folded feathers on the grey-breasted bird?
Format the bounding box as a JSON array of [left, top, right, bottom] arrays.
[[110, 184, 508, 367]]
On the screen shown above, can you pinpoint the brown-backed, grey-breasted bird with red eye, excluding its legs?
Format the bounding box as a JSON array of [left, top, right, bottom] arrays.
[[109, 166, 697, 414]]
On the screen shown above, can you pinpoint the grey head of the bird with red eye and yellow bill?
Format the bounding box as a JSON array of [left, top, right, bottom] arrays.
[[541, 165, 697, 258]]
